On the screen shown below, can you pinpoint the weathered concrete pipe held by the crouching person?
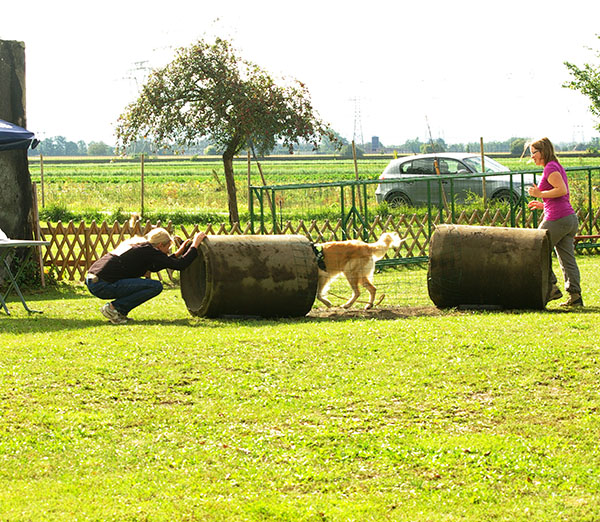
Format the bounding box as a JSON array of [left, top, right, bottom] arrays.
[[181, 235, 318, 317]]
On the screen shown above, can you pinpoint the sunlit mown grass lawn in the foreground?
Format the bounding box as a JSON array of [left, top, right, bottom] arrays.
[[0, 256, 600, 522]]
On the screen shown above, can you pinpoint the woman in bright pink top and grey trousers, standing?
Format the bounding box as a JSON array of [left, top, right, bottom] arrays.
[[528, 138, 583, 306]]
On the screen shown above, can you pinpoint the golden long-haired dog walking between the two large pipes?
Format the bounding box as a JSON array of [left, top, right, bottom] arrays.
[[317, 232, 404, 310]]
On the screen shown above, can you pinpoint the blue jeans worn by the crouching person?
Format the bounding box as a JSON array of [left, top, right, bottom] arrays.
[[85, 277, 162, 315]]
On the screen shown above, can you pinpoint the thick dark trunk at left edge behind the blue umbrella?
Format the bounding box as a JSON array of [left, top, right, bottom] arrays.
[[0, 40, 33, 239]]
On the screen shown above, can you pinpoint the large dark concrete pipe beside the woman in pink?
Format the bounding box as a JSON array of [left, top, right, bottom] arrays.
[[427, 225, 551, 309]]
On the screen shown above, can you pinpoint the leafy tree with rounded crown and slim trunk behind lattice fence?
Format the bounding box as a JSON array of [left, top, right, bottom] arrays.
[[116, 39, 336, 223]]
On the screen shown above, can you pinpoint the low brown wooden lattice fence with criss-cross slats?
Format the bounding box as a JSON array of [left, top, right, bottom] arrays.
[[40, 209, 600, 281]]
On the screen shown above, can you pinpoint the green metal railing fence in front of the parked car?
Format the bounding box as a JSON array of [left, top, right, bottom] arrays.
[[249, 167, 600, 263]]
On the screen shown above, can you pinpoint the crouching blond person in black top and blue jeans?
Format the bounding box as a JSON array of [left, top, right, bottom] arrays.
[[85, 228, 206, 324]]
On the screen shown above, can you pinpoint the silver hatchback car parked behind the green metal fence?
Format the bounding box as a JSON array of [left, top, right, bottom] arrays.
[[375, 152, 533, 206]]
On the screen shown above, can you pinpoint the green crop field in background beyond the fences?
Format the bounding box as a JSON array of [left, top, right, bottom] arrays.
[[29, 152, 600, 221]]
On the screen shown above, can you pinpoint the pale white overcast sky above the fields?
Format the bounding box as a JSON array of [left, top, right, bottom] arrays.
[[0, 0, 600, 145]]
